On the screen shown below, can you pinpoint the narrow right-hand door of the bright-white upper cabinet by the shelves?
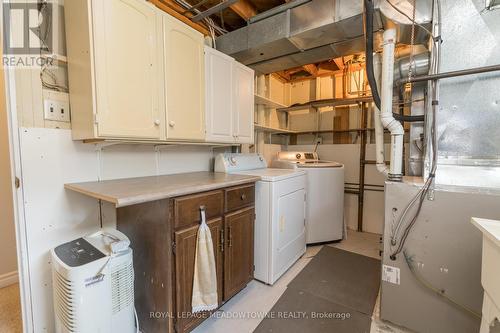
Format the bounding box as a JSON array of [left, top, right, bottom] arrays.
[[233, 62, 254, 143]]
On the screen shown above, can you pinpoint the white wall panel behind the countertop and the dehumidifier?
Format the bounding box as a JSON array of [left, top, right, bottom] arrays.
[[20, 128, 225, 332]]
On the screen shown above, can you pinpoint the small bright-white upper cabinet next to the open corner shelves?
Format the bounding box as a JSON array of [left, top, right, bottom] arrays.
[[205, 47, 254, 143]]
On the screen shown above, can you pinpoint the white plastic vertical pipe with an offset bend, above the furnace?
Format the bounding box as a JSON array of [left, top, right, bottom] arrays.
[[380, 29, 404, 180]]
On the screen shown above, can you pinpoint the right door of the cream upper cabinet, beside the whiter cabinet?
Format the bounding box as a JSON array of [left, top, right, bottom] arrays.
[[163, 15, 205, 141]]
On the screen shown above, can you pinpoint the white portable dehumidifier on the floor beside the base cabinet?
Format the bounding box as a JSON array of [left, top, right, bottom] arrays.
[[51, 229, 136, 333]]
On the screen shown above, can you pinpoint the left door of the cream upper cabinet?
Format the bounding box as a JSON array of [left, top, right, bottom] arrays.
[[92, 0, 165, 139]]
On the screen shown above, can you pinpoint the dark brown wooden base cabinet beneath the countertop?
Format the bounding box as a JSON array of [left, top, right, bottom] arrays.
[[117, 183, 255, 333]]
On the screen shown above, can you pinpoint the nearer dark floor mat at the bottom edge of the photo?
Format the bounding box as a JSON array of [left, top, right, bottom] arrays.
[[254, 289, 371, 333]]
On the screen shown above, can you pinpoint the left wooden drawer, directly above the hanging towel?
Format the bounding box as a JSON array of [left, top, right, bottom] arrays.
[[173, 190, 224, 228]]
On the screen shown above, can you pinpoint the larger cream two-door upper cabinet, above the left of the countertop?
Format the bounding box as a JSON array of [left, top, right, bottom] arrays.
[[64, 0, 205, 142]]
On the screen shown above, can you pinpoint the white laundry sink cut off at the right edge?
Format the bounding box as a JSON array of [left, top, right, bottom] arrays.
[[471, 217, 500, 333]]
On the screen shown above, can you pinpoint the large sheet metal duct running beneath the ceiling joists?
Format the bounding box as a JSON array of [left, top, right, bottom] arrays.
[[216, 0, 431, 74]]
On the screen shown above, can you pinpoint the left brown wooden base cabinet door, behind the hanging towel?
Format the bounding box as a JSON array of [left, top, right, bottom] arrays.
[[174, 218, 223, 332]]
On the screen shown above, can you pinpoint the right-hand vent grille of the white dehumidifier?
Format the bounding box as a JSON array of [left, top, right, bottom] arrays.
[[111, 262, 134, 314]]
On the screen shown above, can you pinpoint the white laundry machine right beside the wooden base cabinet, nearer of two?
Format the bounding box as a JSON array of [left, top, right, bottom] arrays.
[[215, 153, 306, 285]]
